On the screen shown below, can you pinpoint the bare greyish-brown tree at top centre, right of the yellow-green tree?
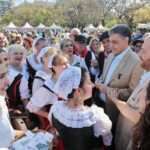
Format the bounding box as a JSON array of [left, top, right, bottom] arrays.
[[57, 0, 104, 27]]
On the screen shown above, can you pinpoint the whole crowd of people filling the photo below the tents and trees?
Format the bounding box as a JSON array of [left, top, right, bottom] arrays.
[[0, 24, 150, 150]]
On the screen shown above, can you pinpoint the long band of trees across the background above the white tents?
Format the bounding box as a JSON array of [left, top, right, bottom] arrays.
[[0, 0, 150, 28]]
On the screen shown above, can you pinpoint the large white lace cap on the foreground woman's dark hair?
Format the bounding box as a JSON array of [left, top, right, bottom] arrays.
[[54, 66, 81, 100]]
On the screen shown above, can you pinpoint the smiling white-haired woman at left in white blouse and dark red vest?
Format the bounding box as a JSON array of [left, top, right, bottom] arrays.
[[7, 44, 29, 108]]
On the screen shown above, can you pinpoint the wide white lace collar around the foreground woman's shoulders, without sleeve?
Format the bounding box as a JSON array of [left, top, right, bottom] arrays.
[[50, 102, 96, 128]]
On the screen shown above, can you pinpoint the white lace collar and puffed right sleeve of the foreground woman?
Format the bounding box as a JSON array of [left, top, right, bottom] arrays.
[[49, 101, 112, 145]]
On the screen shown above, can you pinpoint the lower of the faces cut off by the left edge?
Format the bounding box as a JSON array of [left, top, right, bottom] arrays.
[[0, 72, 9, 91]]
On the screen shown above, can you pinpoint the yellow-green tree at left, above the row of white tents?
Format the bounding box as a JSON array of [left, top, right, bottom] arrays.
[[1, 4, 65, 26]]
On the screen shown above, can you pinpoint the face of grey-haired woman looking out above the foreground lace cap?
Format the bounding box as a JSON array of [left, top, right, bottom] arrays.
[[63, 41, 73, 56]]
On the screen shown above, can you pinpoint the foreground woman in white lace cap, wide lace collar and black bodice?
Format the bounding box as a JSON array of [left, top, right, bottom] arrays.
[[49, 66, 112, 150]]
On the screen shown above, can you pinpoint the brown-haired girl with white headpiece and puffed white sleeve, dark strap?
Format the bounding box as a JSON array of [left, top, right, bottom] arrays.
[[27, 53, 68, 118]]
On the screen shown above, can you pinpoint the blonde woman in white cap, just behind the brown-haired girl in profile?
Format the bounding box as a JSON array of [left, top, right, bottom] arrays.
[[32, 47, 58, 94]]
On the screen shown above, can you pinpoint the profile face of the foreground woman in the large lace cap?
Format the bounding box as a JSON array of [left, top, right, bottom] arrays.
[[81, 73, 93, 100]]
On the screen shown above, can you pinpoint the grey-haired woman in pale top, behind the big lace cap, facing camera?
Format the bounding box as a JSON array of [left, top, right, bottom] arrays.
[[60, 38, 87, 69]]
